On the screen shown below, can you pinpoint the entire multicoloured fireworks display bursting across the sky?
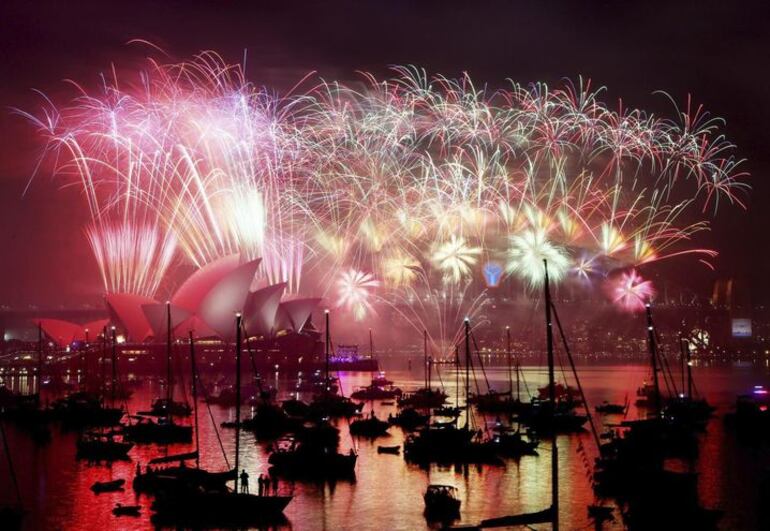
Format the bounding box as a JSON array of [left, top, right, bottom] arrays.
[[25, 52, 747, 320]]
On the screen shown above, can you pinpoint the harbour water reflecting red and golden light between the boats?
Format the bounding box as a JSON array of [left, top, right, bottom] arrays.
[[0, 358, 770, 530]]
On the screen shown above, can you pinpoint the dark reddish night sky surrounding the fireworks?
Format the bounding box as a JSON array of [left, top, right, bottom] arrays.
[[0, 0, 770, 307]]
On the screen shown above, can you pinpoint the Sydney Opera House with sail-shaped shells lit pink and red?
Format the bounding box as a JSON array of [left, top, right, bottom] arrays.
[[29, 255, 322, 372]]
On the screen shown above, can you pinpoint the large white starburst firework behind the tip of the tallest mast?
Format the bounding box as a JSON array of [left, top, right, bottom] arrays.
[[506, 229, 570, 287]]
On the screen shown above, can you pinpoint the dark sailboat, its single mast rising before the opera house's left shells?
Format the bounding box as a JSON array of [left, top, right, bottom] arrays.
[[123, 302, 192, 444]]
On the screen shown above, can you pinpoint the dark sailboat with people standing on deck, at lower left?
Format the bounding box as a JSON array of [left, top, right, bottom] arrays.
[[152, 313, 292, 526]]
